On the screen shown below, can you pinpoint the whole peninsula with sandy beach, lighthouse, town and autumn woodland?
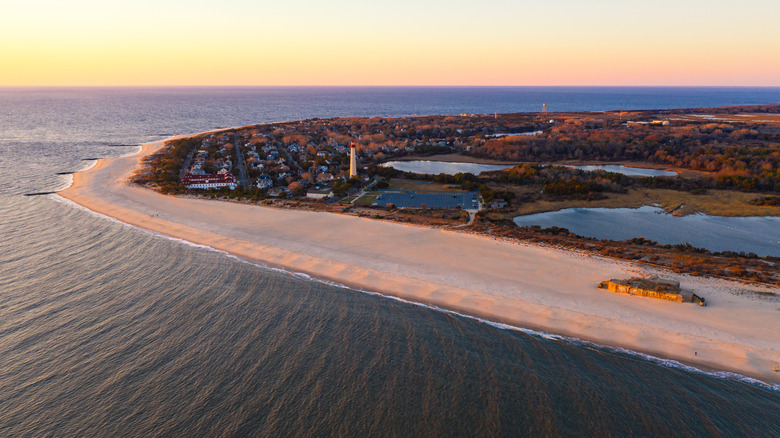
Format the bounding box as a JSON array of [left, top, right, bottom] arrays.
[[59, 105, 780, 383]]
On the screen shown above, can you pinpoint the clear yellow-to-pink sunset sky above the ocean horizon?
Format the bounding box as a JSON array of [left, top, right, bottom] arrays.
[[0, 0, 780, 86]]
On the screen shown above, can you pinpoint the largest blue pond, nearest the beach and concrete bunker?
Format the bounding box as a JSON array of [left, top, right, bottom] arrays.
[[514, 206, 780, 257]]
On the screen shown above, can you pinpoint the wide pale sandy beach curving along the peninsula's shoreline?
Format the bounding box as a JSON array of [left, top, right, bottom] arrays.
[[59, 142, 780, 383]]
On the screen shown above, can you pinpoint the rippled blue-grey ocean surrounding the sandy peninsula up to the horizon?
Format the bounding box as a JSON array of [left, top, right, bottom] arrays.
[[0, 88, 780, 437]]
